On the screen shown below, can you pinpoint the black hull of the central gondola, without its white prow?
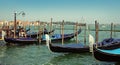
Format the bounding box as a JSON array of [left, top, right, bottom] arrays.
[[49, 43, 89, 53]]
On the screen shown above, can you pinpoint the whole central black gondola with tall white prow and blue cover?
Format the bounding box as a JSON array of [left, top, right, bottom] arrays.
[[46, 34, 89, 53]]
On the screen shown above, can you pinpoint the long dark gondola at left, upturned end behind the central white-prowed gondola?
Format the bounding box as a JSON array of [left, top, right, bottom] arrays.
[[4, 30, 80, 44]]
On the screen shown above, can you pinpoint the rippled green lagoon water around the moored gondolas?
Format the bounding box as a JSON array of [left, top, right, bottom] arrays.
[[0, 24, 120, 65]]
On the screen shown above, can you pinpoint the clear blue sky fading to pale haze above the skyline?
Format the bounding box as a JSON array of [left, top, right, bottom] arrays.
[[0, 0, 120, 23]]
